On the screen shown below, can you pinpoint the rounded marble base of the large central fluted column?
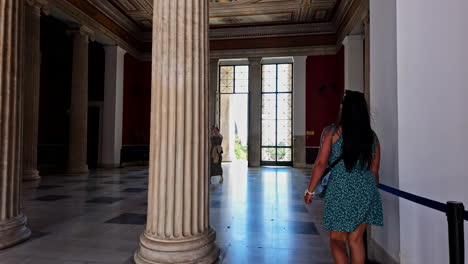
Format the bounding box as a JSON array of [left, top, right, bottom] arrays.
[[134, 229, 219, 264]]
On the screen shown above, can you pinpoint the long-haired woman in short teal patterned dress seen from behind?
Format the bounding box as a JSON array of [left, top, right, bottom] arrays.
[[304, 91, 383, 264]]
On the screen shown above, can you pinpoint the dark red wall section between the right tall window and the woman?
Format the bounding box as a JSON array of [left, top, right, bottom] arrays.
[[306, 48, 344, 147]]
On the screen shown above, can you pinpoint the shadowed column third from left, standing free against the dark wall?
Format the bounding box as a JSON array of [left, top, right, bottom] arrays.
[[68, 26, 92, 174]]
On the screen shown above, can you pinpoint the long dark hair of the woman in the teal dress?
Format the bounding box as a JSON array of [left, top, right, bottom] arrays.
[[340, 91, 374, 171]]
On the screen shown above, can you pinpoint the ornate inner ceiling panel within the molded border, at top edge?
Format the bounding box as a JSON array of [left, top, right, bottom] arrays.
[[86, 0, 341, 32]]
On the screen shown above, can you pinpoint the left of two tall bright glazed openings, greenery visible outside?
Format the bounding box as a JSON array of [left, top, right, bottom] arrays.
[[219, 65, 249, 162]]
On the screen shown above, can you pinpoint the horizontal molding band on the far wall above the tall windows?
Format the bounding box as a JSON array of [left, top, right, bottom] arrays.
[[210, 45, 337, 59]]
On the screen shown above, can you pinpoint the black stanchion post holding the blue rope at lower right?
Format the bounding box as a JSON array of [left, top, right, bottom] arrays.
[[447, 202, 465, 264]]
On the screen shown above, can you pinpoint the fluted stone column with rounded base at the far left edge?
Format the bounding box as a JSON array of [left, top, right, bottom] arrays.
[[0, 0, 31, 249]]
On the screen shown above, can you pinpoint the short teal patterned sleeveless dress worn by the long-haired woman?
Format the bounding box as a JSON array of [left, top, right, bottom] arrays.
[[323, 127, 383, 233]]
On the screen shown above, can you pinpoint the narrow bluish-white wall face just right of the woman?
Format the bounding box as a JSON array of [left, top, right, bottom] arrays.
[[370, 0, 400, 263]]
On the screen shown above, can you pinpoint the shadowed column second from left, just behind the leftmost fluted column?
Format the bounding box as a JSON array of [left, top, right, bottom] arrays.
[[22, 0, 47, 181]]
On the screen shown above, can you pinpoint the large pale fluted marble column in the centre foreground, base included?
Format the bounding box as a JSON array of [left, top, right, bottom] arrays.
[[134, 0, 219, 263]]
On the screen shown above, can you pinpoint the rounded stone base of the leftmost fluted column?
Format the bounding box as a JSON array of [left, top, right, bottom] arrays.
[[0, 214, 31, 249]]
